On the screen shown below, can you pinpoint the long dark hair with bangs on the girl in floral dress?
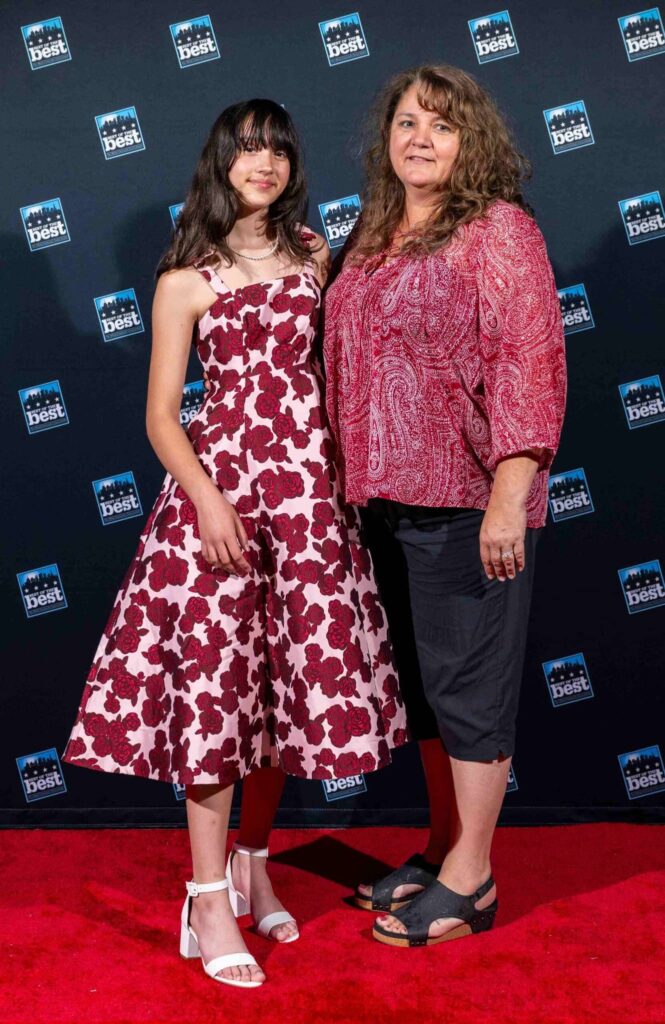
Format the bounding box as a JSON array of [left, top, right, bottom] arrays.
[[156, 99, 311, 278]]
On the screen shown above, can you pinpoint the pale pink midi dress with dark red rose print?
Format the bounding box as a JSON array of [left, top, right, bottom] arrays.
[[65, 266, 407, 785]]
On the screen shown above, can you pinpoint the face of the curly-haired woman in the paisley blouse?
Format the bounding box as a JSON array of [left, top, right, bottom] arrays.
[[389, 85, 460, 193]]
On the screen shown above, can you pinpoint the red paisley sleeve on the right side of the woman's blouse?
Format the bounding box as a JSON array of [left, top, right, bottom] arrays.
[[477, 204, 566, 472]]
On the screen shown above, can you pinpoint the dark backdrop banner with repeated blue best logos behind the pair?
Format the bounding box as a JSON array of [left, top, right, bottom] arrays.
[[0, 0, 665, 824]]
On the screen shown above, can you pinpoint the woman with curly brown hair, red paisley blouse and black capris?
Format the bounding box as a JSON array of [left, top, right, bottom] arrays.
[[324, 67, 566, 946]]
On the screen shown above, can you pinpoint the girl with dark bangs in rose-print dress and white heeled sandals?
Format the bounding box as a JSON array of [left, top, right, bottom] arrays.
[[65, 99, 406, 987]]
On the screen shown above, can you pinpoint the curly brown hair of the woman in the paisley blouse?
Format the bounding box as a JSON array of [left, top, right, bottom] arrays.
[[351, 65, 533, 262]]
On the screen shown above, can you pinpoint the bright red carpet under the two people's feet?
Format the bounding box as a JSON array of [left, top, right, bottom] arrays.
[[0, 824, 665, 1024]]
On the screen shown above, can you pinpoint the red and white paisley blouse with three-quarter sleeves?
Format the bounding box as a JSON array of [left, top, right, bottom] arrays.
[[324, 200, 566, 526]]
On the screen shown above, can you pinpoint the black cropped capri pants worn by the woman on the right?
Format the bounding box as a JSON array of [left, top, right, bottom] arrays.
[[362, 499, 541, 761]]
